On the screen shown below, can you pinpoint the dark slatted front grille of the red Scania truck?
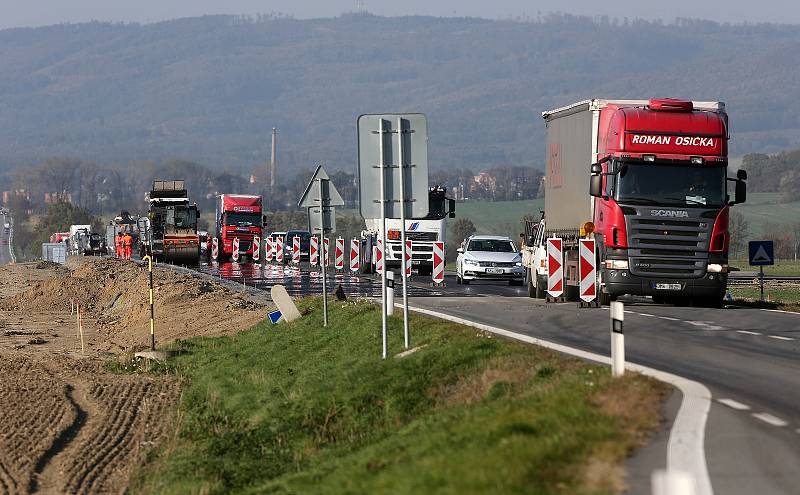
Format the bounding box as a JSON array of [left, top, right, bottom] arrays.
[[625, 215, 713, 278]]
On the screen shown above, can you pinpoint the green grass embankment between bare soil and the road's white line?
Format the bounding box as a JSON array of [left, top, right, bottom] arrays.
[[133, 300, 666, 494]]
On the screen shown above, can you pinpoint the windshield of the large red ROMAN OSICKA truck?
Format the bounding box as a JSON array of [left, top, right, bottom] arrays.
[[615, 163, 727, 207]]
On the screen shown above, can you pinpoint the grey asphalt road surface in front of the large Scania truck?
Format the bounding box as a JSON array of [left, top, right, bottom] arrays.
[[412, 276, 800, 495]]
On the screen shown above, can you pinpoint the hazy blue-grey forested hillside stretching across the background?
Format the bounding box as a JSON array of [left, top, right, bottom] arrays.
[[0, 15, 800, 173]]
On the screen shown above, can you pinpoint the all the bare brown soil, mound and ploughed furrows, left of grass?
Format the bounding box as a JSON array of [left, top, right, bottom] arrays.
[[0, 259, 266, 494]]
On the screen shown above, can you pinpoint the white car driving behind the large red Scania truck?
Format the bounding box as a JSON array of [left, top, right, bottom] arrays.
[[456, 235, 525, 285]]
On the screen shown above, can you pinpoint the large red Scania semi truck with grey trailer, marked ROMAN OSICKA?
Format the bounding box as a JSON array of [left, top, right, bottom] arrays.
[[523, 99, 747, 306]]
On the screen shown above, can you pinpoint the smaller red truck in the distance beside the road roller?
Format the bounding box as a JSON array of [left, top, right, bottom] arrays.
[[214, 194, 264, 261]]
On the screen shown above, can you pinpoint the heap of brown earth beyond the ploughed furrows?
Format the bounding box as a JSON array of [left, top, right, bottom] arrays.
[[0, 259, 266, 352]]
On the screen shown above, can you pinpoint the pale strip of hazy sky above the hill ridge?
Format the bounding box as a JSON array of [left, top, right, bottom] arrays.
[[0, 0, 800, 29]]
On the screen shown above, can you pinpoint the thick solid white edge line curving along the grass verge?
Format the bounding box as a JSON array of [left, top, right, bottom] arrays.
[[406, 303, 714, 495]]
